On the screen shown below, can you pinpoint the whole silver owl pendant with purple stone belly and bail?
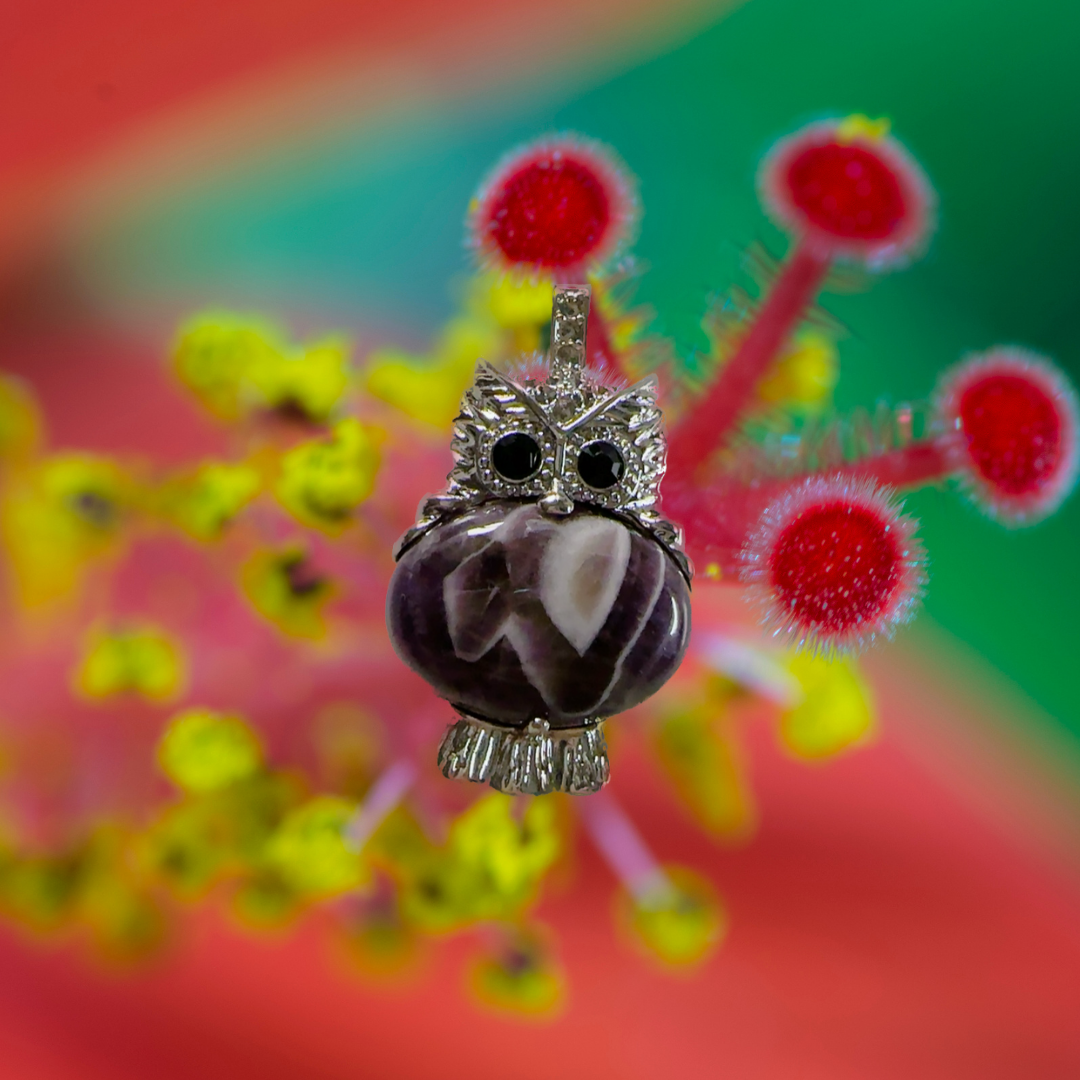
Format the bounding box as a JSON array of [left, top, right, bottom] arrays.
[[387, 286, 691, 795]]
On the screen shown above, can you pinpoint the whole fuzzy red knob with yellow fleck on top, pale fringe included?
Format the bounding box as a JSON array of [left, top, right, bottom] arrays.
[[758, 117, 934, 269]]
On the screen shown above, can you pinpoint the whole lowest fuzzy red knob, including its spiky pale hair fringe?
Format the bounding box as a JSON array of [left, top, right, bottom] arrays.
[[742, 476, 926, 651]]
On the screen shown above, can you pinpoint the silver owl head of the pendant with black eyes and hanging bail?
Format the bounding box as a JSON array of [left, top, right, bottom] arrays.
[[395, 285, 690, 578]]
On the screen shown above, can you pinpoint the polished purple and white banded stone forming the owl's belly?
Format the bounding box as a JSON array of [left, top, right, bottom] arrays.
[[387, 500, 690, 727]]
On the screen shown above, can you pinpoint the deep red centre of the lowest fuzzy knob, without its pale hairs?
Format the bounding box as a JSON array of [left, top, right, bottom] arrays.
[[769, 502, 902, 636]]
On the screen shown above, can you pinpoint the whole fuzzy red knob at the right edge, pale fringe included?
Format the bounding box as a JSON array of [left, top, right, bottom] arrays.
[[935, 348, 1080, 525]]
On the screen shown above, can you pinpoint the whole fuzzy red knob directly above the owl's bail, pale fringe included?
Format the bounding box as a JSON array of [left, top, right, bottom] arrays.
[[468, 135, 637, 280]]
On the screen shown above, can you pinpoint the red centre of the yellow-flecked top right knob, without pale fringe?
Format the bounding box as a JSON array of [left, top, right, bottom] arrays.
[[786, 143, 907, 240]]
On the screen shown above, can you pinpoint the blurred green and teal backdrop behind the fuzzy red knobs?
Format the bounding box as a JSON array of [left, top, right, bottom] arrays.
[[86, 0, 1080, 743]]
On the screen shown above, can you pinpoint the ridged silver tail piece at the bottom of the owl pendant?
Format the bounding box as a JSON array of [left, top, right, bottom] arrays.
[[438, 713, 611, 795]]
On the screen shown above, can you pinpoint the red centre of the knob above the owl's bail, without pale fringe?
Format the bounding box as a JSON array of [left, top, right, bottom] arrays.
[[487, 159, 610, 268]]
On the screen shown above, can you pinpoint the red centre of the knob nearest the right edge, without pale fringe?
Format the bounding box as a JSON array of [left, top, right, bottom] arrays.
[[960, 375, 1062, 495]]
